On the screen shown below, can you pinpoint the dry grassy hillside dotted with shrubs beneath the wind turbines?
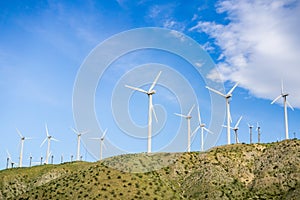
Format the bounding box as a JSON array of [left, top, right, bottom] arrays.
[[0, 140, 300, 199]]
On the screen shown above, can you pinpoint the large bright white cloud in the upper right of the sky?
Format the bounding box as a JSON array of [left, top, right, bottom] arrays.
[[190, 0, 300, 108]]
